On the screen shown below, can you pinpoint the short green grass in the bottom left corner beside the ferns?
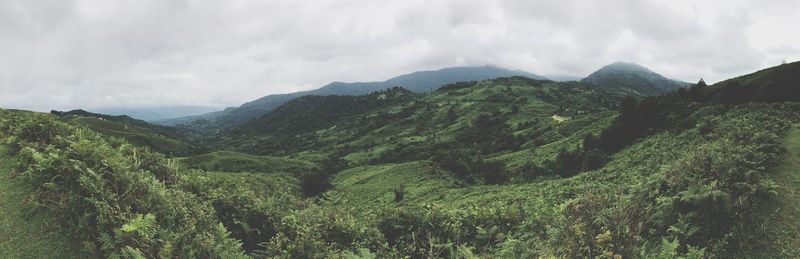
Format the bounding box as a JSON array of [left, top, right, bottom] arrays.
[[0, 147, 82, 258]]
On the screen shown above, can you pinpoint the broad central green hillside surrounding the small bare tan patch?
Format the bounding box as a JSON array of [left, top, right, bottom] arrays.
[[209, 77, 624, 180]]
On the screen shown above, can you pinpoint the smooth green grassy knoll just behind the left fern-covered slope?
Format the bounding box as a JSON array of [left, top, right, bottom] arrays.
[[179, 151, 318, 175]]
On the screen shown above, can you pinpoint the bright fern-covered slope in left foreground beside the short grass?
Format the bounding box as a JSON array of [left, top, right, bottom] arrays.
[[0, 110, 244, 258]]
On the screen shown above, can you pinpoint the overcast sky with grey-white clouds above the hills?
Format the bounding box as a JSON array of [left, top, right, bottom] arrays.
[[0, 0, 800, 111]]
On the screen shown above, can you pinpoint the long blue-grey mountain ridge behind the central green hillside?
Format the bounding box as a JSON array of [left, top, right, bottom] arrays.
[[156, 66, 547, 130]]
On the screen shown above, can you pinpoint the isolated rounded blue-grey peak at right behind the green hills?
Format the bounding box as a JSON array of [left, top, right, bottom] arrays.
[[581, 62, 691, 96]]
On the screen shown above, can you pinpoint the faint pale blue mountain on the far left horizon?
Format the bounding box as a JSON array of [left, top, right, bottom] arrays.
[[91, 106, 221, 121]]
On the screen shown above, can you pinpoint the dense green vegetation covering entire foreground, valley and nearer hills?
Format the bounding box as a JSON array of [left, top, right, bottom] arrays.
[[0, 63, 800, 258]]
